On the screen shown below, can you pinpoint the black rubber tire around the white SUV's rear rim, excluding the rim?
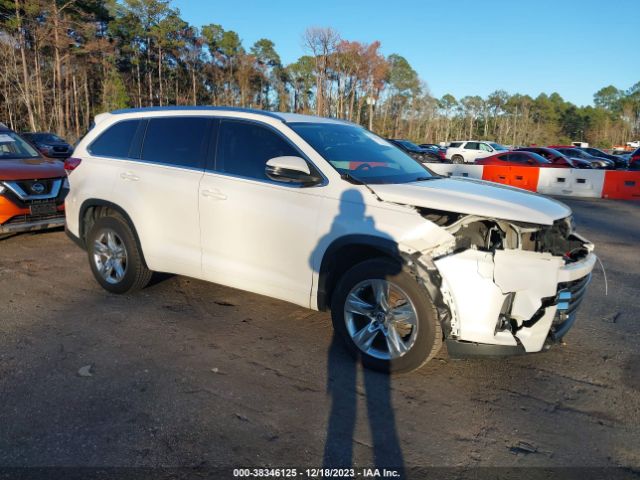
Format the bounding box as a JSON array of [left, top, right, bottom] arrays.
[[86, 215, 153, 294]]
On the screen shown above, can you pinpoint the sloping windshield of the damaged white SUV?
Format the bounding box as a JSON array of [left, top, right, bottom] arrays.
[[289, 123, 436, 184]]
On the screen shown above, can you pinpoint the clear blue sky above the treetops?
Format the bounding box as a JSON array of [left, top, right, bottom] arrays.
[[172, 0, 640, 105]]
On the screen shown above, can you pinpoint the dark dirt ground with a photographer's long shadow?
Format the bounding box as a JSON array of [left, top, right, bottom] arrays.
[[0, 200, 640, 476]]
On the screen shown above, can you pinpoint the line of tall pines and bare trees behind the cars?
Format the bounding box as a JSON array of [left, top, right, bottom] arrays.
[[0, 0, 640, 147]]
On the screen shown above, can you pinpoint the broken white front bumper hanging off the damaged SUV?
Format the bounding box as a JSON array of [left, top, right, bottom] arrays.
[[408, 216, 596, 357]]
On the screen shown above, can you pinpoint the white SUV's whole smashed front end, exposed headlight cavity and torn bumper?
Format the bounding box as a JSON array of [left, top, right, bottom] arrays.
[[407, 209, 596, 356]]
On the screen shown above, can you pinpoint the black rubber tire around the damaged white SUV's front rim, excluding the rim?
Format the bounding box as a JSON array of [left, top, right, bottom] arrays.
[[331, 258, 442, 373]]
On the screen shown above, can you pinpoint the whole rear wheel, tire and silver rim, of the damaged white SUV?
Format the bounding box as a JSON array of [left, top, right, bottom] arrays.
[[86, 216, 152, 293]]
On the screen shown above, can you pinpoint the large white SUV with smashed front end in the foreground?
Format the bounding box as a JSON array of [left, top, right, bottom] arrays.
[[66, 107, 596, 371]]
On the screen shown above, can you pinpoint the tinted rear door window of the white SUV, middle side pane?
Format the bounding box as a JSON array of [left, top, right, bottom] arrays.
[[142, 117, 213, 169]]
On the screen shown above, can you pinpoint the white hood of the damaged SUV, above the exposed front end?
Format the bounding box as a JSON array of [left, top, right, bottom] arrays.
[[369, 178, 571, 225]]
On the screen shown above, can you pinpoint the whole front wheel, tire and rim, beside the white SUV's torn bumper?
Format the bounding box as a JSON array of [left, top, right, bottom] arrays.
[[331, 259, 442, 372]]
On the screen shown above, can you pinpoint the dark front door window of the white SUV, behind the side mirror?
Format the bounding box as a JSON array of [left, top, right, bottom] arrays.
[[216, 120, 300, 180]]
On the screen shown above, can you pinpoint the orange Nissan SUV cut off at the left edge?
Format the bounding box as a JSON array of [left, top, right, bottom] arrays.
[[0, 123, 69, 236]]
